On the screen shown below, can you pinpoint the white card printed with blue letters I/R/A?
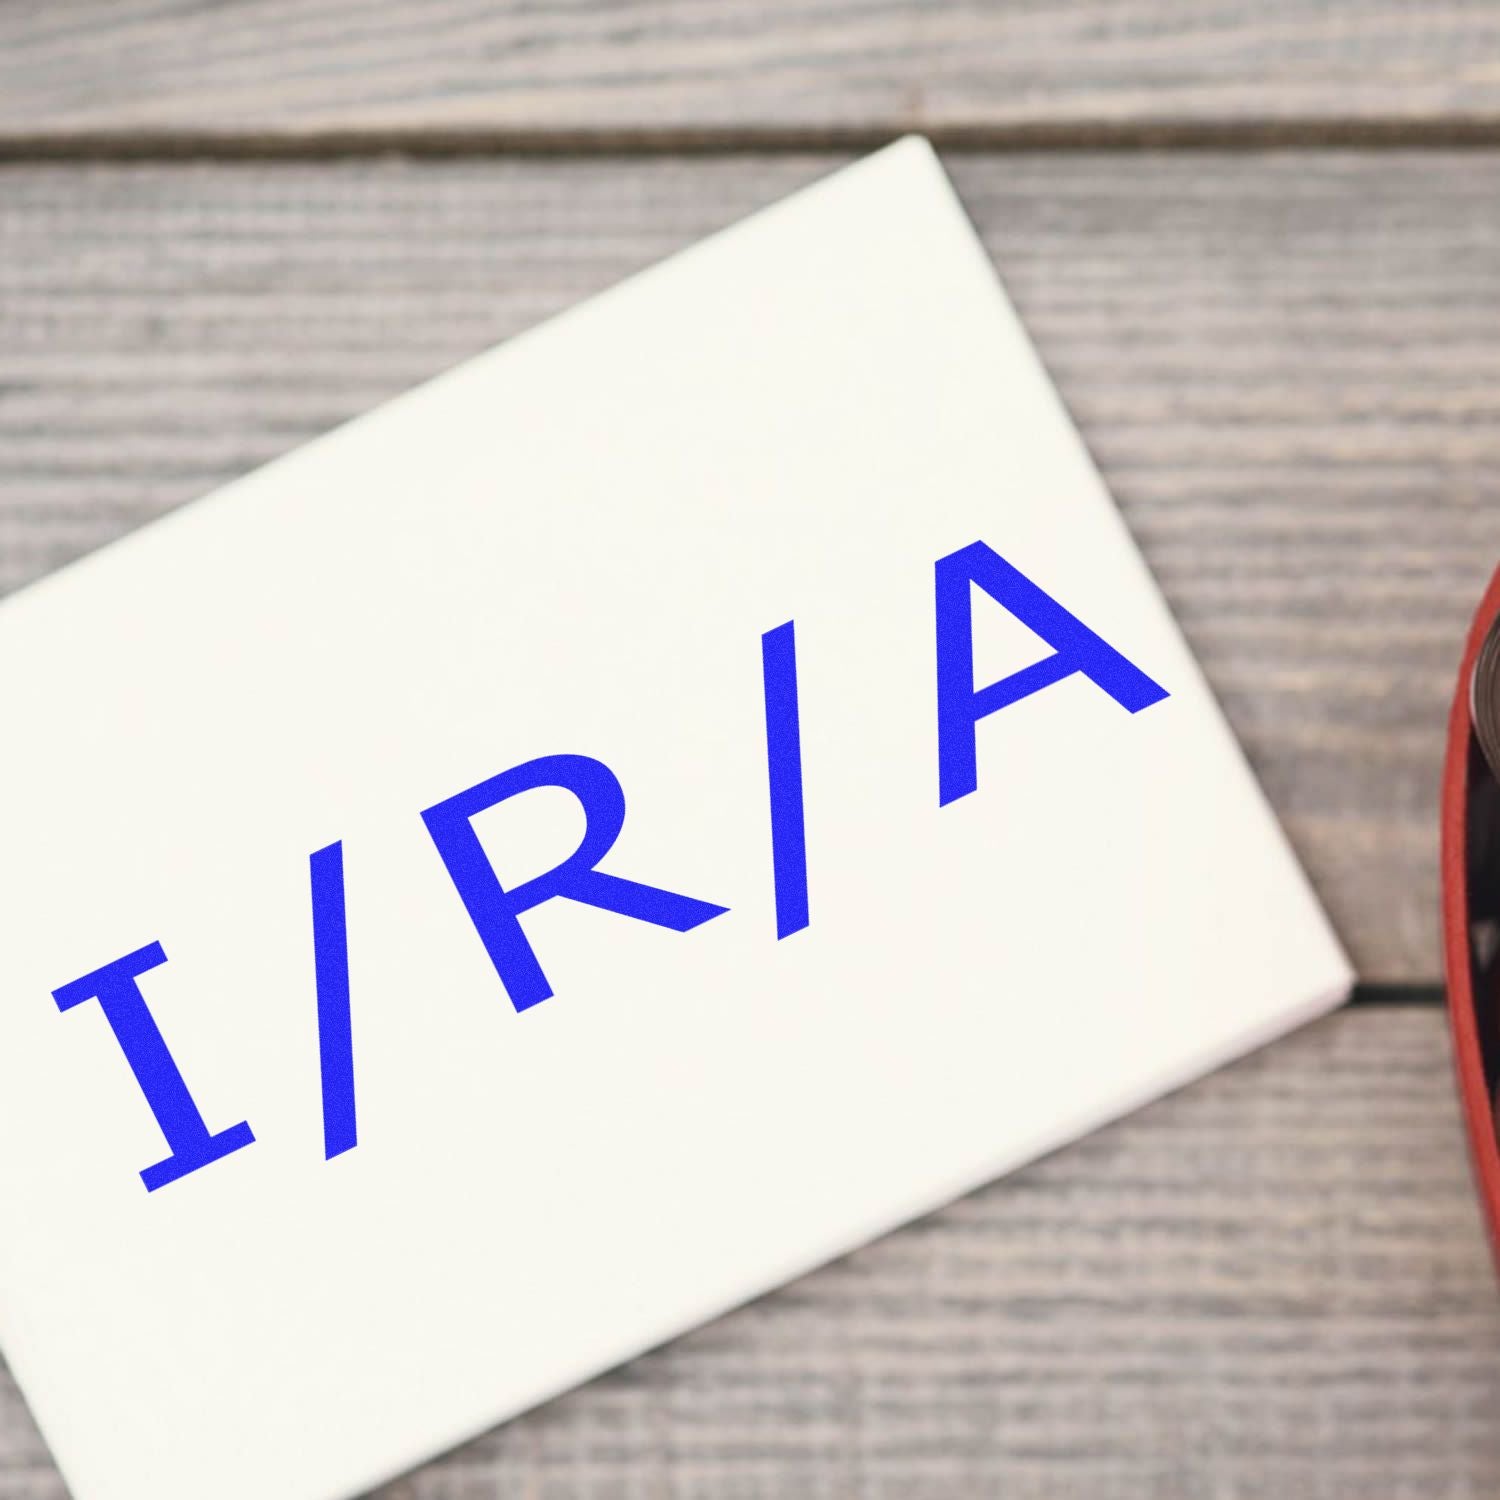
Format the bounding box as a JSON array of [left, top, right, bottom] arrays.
[[0, 140, 1350, 1500]]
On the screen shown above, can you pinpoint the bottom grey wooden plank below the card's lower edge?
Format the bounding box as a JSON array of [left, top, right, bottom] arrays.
[[0, 1007, 1500, 1500]]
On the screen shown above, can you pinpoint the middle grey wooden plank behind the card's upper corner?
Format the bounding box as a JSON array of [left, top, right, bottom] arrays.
[[0, 153, 1500, 980]]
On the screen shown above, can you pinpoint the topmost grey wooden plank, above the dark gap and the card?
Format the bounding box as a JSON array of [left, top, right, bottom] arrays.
[[0, 0, 1500, 146]]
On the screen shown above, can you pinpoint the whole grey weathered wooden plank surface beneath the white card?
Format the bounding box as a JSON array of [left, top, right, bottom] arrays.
[[0, 0, 1500, 1500]]
